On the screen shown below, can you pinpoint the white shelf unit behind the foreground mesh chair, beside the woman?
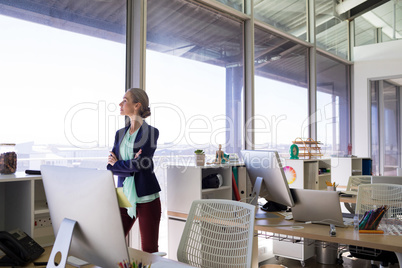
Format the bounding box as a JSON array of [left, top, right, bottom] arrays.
[[167, 164, 251, 259]]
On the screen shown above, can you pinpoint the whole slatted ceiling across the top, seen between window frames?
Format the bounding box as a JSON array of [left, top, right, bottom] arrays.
[[0, 0, 402, 85]]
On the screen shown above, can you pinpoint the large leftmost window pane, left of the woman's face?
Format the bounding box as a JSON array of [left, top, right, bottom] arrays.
[[0, 0, 126, 171]]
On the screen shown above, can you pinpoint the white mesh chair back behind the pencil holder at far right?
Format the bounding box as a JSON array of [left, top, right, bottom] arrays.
[[356, 183, 402, 235]]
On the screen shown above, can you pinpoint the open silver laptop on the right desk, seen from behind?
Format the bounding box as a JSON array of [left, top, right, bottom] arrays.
[[290, 189, 350, 227]]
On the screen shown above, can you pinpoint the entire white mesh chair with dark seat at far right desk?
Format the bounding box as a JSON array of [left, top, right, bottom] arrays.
[[349, 184, 402, 267]]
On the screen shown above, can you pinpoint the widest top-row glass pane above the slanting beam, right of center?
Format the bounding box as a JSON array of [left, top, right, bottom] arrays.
[[254, 0, 307, 41]]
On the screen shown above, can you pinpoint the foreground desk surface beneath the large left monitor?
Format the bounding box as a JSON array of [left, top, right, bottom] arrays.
[[24, 247, 194, 268]]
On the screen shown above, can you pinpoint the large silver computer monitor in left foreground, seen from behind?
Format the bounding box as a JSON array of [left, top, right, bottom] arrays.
[[41, 166, 130, 267]]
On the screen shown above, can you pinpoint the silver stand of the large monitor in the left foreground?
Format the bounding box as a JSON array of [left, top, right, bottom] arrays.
[[46, 218, 77, 268]]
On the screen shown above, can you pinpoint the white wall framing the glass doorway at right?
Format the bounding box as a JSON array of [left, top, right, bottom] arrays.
[[352, 40, 402, 157]]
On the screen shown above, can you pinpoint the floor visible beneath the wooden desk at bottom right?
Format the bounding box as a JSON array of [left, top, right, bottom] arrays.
[[259, 252, 399, 268]]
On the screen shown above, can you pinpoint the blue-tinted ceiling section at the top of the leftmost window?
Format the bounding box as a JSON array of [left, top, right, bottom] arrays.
[[0, 0, 126, 43]]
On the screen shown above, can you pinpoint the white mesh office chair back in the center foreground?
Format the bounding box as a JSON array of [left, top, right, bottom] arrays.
[[177, 199, 255, 268]]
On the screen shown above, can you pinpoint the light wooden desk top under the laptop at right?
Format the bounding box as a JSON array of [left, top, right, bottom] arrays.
[[255, 211, 402, 252]]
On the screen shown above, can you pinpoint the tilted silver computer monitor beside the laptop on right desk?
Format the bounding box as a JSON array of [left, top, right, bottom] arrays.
[[241, 150, 294, 211]]
